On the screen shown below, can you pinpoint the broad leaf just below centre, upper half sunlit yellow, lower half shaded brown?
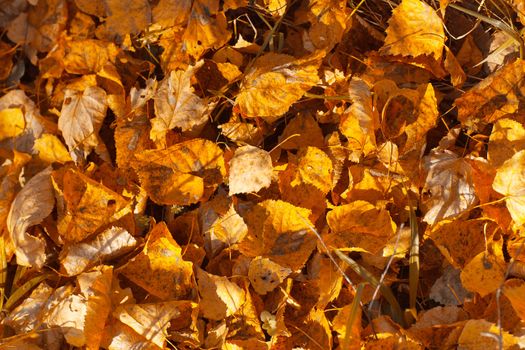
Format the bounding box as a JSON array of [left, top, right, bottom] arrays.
[[239, 200, 317, 271]]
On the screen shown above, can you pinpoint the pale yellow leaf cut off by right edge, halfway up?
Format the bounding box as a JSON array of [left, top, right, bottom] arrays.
[[492, 150, 525, 226]]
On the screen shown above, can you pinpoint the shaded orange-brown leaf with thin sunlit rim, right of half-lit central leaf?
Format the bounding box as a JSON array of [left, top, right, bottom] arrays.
[[323, 200, 396, 254]]
